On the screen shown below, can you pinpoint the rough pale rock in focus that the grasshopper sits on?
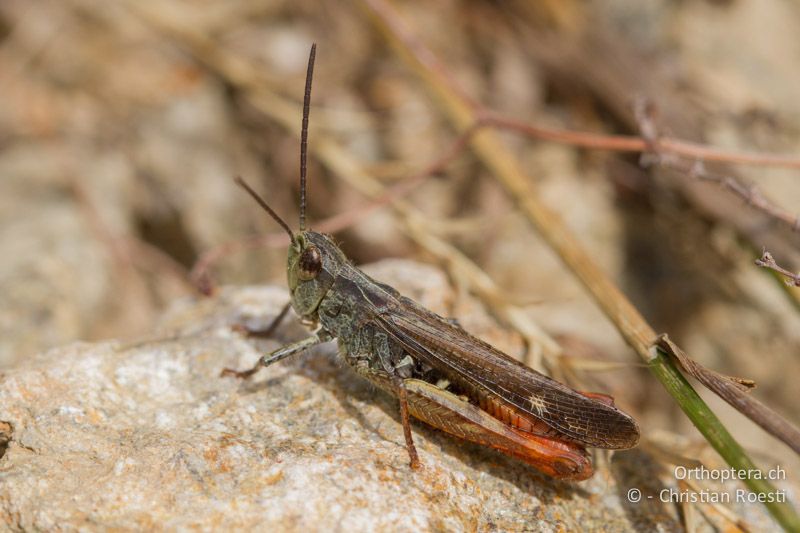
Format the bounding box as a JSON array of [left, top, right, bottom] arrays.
[[0, 261, 780, 531]]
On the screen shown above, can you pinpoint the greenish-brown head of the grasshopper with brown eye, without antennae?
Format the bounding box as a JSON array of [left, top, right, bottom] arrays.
[[287, 231, 347, 318]]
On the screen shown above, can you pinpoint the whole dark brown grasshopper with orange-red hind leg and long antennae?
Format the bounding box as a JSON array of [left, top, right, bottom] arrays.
[[223, 45, 639, 481]]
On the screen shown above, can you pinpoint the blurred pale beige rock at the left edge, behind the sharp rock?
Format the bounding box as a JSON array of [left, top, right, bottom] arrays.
[[0, 148, 113, 369]]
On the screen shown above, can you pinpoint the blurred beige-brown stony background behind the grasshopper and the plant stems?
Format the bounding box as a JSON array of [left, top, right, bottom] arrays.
[[0, 0, 800, 494]]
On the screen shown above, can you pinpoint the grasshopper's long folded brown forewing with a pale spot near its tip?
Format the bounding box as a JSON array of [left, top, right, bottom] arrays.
[[380, 298, 639, 449]]
